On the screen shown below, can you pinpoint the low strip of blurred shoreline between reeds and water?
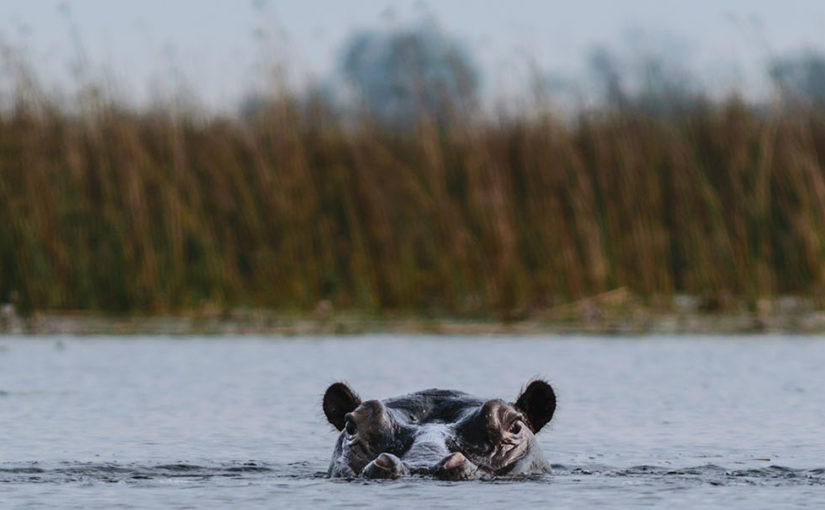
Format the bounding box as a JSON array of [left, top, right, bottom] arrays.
[[6, 289, 825, 336]]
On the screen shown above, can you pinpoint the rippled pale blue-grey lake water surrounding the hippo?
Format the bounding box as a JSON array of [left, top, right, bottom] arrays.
[[0, 336, 825, 509]]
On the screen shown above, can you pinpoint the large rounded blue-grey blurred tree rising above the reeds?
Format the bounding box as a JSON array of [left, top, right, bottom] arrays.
[[340, 22, 479, 123]]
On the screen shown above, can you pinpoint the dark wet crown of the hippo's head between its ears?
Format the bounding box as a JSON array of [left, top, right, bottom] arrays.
[[383, 389, 484, 424]]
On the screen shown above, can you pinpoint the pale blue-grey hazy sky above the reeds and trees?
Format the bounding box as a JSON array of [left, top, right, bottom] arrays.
[[0, 0, 825, 109]]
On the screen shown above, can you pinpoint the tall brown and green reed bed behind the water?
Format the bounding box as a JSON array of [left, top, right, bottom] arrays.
[[0, 91, 825, 316]]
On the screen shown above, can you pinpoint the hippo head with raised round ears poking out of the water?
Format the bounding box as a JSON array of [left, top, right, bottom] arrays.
[[323, 380, 556, 480]]
